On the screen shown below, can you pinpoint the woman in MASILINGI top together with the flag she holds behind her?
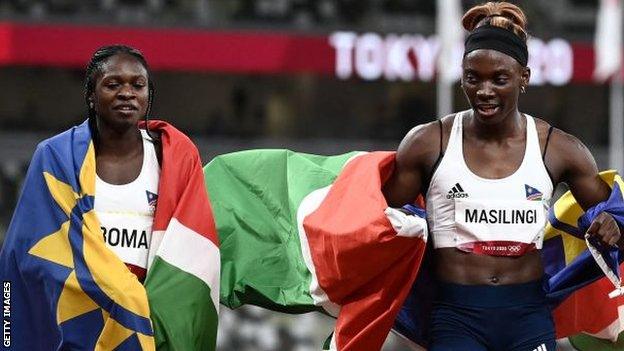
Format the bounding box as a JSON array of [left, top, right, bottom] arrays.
[[205, 2, 624, 351]]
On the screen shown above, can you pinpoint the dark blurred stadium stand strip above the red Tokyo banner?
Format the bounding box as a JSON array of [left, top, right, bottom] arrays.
[[0, 0, 597, 39]]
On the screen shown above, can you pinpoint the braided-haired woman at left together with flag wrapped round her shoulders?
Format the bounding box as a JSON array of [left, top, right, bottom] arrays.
[[0, 46, 219, 351]]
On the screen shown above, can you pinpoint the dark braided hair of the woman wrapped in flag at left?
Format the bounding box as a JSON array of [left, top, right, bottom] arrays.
[[84, 45, 156, 143]]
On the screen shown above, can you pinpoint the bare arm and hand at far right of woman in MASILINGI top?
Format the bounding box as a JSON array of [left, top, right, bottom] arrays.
[[547, 129, 624, 248]]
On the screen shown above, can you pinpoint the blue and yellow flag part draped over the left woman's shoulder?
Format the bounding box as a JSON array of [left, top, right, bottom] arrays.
[[0, 122, 154, 350]]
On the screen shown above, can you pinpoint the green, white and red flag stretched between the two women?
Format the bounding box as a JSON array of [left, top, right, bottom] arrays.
[[204, 150, 426, 350]]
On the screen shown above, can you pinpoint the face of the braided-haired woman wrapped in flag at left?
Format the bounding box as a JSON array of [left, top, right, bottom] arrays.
[[90, 53, 149, 130]]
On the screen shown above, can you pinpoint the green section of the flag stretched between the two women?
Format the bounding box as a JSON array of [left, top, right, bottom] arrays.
[[204, 150, 357, 313]]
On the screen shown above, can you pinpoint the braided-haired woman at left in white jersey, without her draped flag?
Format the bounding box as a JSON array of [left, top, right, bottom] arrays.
[[85, 46, 162, 281]]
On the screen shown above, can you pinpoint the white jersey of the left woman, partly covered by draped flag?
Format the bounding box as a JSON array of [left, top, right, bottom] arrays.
[[94, 130, 160, 280]]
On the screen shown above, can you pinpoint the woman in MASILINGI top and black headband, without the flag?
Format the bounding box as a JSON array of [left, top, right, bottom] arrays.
[[384, 2, 624, 351]]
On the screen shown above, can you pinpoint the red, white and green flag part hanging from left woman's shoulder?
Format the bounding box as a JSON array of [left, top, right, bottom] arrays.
[[145, 121, 220, 351]]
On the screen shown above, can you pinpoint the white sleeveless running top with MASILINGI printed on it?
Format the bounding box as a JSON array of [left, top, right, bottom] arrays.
[[426, 111, 553, 256]]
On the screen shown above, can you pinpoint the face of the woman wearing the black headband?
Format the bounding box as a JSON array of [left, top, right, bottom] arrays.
[[462, 49, 530, 124]]
